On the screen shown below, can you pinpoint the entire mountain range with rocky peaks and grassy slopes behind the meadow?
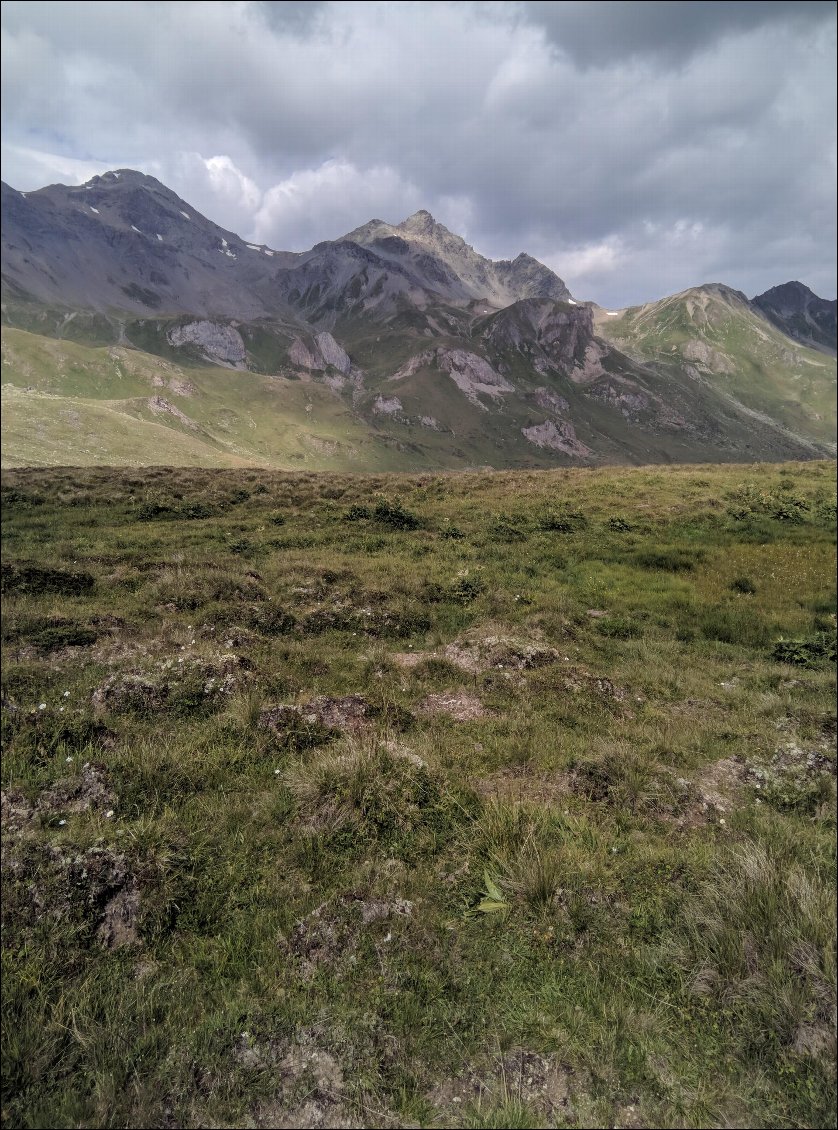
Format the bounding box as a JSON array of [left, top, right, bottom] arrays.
[[2, 170, 836, 470]]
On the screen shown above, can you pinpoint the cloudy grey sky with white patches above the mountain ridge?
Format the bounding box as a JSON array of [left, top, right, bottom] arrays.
[[2, 0, 836, 308]]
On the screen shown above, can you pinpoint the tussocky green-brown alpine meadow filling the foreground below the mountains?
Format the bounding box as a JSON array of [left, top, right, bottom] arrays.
[[2, 463, 836, 1127]]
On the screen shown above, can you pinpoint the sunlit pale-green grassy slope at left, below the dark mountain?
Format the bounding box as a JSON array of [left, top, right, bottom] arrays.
[[2, 328, 426, 469]]
